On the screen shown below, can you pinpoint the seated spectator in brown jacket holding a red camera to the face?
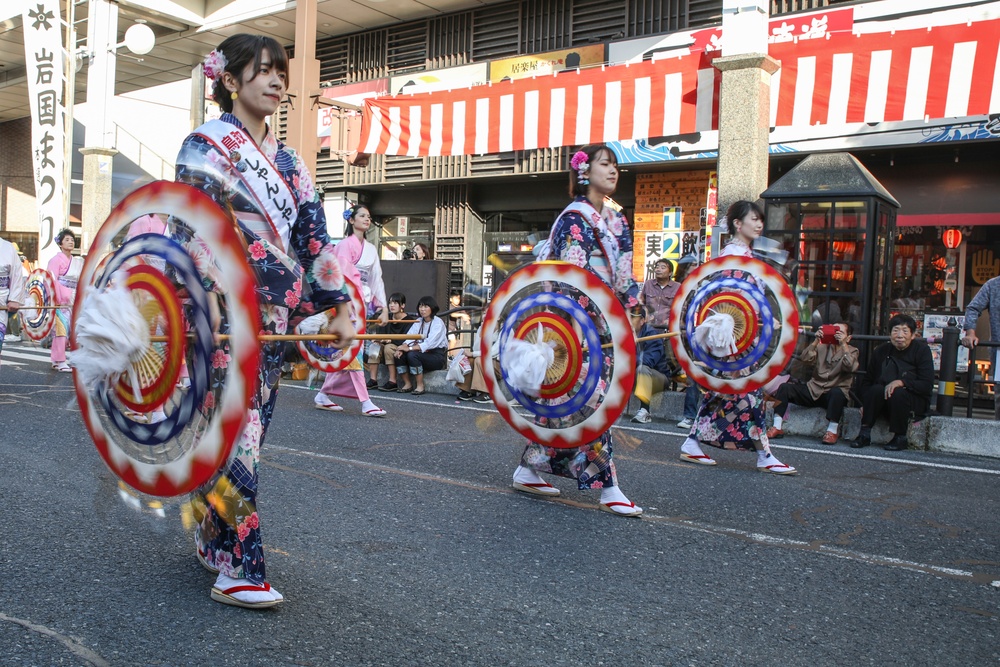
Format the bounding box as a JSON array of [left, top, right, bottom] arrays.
[[767, 322, 858, 445]]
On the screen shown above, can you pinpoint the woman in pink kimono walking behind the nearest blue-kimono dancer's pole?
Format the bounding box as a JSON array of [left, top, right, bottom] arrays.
[[314, 204, 389, 417]]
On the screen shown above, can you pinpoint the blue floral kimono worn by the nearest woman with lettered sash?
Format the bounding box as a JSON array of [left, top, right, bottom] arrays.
[[177, 114, 349, 583]]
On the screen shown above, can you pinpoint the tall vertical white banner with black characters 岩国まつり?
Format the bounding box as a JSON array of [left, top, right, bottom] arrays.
[[23, 0, 66, 266]]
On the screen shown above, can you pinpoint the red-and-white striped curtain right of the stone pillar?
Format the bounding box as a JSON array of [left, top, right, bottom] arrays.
[[770, 20, 1000, 126]]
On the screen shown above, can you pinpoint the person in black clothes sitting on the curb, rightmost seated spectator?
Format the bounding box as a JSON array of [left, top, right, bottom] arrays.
[[851, 315, 934, 452]]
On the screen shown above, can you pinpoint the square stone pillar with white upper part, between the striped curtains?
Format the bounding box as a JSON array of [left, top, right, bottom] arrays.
[[712, 0, 780, 245]]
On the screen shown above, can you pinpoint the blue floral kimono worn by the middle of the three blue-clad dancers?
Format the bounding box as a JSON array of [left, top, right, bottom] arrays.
[[521, 197, 639, 489]]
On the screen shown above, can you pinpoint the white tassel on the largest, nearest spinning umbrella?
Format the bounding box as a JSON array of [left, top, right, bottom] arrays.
[[68, 279, 149, 397]]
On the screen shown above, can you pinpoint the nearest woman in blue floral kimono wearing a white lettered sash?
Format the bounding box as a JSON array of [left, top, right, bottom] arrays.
[[177, 34, 354, 608]]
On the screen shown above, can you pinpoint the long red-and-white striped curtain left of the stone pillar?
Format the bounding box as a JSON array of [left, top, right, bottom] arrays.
[[358, 55, 717, 156]]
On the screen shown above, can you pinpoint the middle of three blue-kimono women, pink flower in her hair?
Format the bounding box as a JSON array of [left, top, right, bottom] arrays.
[[514, 144, 642, 516]]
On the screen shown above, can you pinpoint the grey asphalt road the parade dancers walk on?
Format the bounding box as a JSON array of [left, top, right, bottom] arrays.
[[0, 344, 1000, 667]]
